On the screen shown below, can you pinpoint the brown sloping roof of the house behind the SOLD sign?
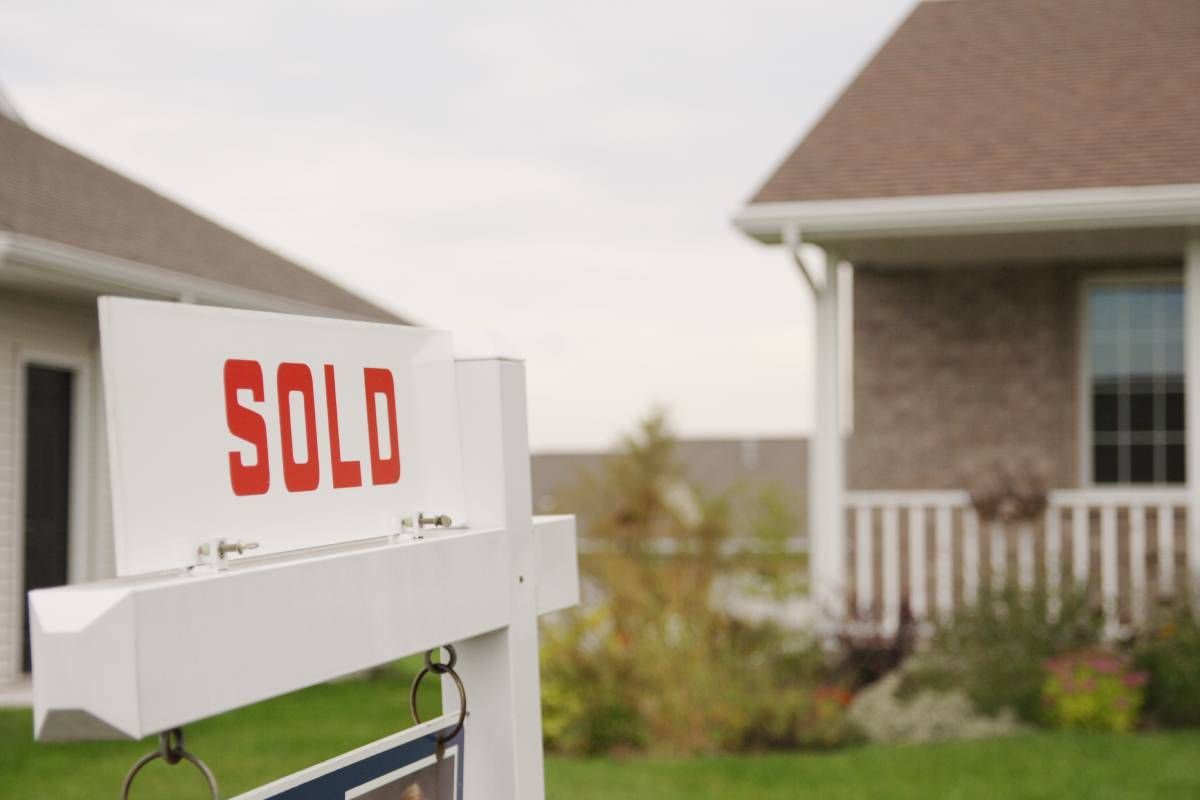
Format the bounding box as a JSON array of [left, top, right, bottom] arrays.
[[0, 115, 402, 321]]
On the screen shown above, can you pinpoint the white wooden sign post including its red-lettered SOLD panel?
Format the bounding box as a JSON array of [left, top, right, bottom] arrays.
[[23, 299, 578, 800]]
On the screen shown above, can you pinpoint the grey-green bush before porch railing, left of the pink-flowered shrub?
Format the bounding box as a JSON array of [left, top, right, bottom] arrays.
[[901, 589, 1103, 722]]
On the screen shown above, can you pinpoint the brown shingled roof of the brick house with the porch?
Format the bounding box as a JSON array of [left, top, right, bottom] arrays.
[[751, 0, 1200, 204]]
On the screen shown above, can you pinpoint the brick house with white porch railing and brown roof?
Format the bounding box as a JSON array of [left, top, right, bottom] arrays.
[[736, 0, 1200, 632]]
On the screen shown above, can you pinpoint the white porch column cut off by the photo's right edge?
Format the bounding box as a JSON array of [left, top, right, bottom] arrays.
[[1183, 230, 1200, 600]]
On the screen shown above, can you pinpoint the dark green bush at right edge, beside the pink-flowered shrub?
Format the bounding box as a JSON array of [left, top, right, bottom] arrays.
[[1134, 609, 1200, 728]]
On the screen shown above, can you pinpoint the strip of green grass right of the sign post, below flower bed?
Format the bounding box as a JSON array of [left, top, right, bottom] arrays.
[[547, 733, 1200, 800]]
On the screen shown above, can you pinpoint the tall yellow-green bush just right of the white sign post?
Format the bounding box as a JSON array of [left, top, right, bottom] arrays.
[[541, 416, 852, 754]]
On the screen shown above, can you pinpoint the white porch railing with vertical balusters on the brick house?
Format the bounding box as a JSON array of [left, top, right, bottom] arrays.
[[842, 487, 1200, 636]]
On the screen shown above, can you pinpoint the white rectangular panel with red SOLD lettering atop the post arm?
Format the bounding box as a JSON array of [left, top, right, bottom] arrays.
[[100, 297, 463, 576]]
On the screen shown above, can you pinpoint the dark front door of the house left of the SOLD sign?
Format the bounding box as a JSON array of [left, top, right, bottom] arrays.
[[23, 365, 74, 672]]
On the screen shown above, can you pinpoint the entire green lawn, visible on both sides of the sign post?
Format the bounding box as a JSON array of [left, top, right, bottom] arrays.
[[0, 666, 1200, 800]]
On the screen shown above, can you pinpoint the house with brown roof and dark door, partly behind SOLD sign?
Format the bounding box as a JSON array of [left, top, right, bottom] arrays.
[[0, 97, 403, 684]]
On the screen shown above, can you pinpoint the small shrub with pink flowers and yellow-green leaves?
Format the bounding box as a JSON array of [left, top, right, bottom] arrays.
[[1042, 650, 1146, 733]]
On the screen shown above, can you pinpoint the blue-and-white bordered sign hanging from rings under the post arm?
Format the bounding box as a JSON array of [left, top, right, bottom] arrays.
[[234, 714, 464, 800]]
